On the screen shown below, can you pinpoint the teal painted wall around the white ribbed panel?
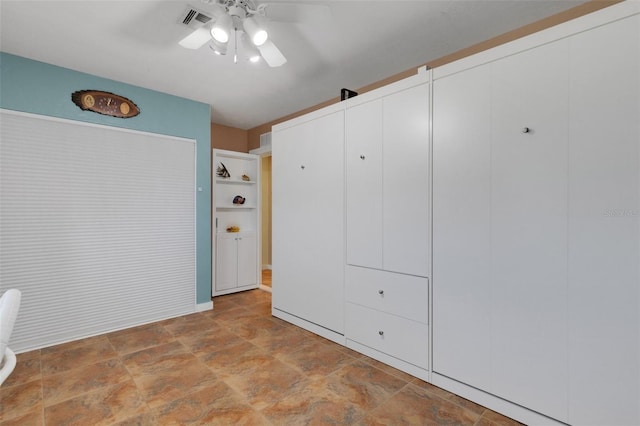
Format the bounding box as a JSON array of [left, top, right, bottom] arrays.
[[0, 52, 211, 303]]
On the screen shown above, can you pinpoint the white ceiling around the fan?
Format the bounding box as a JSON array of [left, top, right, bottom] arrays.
[[0, 0, 584, 129]]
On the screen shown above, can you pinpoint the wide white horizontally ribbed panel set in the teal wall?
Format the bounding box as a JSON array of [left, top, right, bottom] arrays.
[[0, 110, 195, 352]]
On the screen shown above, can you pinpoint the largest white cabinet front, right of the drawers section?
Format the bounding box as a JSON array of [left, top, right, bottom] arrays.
[[433, 7, 640, 425]]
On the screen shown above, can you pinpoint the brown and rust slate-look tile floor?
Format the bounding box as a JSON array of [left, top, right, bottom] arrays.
[[0, 290, 518, 426]]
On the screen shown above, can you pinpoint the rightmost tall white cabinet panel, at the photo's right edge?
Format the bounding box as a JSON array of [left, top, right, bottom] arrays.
[[568, 15, 640, 425]]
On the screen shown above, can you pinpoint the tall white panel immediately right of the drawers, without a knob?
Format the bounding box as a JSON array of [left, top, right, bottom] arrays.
[[433, 65, 492, 389]]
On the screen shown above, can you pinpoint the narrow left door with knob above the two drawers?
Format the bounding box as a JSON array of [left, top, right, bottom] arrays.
[[345, 99, 383, 269]]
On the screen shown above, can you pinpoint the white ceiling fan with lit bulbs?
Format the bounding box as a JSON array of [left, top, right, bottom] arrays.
[[179, 0, 287, 67]]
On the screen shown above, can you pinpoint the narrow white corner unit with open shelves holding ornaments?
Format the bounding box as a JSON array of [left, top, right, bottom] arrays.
[[211, 149, 261, 296]]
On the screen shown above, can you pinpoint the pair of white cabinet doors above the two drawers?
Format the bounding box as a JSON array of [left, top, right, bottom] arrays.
[[345, 76, 430, 277]]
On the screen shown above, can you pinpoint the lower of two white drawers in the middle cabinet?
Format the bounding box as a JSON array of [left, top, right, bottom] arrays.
[[345, 303, 429, 368]]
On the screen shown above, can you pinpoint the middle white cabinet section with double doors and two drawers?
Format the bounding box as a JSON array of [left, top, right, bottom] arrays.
[[345, 74, 431, 376]]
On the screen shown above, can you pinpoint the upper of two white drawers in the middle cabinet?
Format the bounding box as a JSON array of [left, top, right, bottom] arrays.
[[346, 266, 429, 324]]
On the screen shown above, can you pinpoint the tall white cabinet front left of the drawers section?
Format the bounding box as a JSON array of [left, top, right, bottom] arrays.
[[272, 111, 344, 334]]
